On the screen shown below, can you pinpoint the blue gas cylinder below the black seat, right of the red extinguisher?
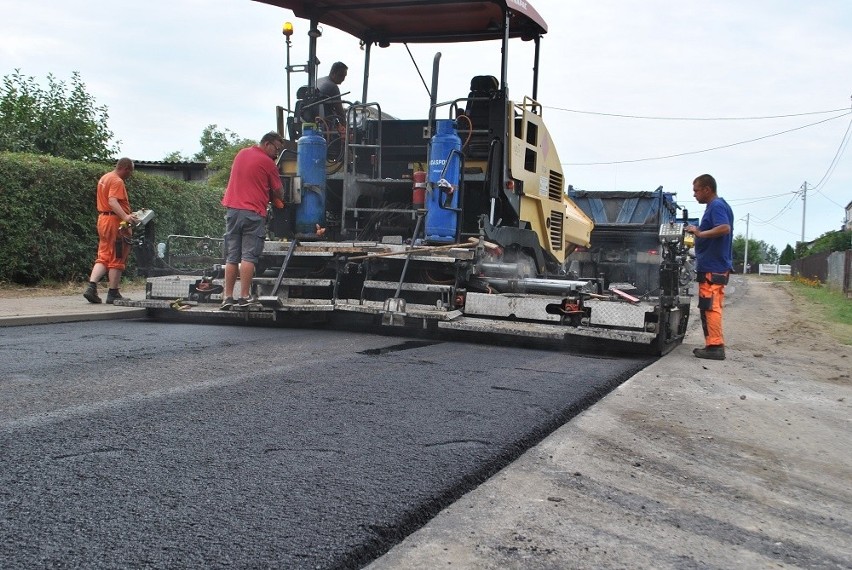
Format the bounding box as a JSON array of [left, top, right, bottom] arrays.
[[426, 119, 461, 243]]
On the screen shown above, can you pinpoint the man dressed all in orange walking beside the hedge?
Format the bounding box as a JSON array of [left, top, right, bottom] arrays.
[[83, 158, 139, 304]]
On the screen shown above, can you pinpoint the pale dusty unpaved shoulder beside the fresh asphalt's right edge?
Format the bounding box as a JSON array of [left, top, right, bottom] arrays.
[[369, 276, 852, 570]]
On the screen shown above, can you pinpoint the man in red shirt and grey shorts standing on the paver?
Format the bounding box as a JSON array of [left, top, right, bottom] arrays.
[[221, 132, 284, 311]]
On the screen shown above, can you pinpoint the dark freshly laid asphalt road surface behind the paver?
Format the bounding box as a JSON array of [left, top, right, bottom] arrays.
[[0, 321, 651, 569]]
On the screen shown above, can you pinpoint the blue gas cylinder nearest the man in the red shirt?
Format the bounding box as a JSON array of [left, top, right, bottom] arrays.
[[296, 123, 327, 236]]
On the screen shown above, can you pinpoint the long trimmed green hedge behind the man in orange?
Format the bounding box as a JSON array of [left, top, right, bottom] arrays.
[[0, 152, 225, 285]]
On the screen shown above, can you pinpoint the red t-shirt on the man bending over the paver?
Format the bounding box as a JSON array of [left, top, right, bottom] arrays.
[[222, 146, 282, 216]]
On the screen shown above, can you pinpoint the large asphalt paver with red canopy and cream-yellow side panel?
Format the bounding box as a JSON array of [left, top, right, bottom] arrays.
[[123, 0, 690, 354]]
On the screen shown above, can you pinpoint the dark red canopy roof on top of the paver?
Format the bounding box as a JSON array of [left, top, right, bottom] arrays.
[[250, 0, 547, 44]]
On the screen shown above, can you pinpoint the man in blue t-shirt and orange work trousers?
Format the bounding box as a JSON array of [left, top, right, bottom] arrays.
[[686, 174, 734, 360]]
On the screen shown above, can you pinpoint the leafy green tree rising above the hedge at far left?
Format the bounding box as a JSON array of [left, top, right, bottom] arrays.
[[0, 69, 120, 162]]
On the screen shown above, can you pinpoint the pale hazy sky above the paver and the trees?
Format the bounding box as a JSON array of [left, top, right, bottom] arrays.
[[0, 0, 852, 251]]
